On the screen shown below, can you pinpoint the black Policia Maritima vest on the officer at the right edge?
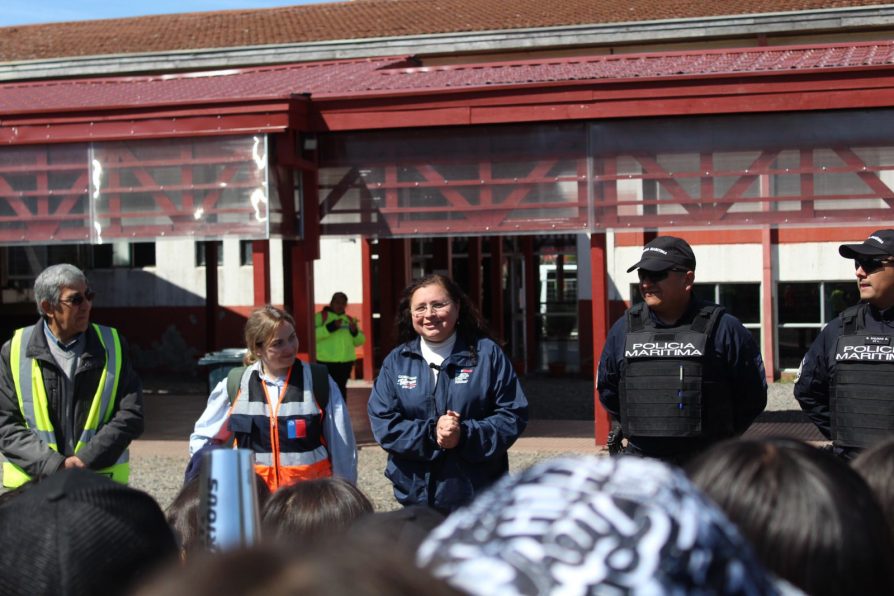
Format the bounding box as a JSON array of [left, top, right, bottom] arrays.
[[831, 304, 894, 448]]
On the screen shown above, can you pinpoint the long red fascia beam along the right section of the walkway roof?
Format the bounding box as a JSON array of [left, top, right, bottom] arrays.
[[311, 68, 894, 131]]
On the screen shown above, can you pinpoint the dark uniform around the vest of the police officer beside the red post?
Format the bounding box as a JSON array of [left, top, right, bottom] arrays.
[[597, 296, 767, 463]]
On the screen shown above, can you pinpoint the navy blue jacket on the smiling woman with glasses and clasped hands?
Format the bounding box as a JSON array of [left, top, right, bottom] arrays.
[[367, 338, 528, 512]]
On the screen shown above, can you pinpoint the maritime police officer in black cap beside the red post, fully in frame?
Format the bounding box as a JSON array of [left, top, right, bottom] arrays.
[[597, 236, 767, 464]]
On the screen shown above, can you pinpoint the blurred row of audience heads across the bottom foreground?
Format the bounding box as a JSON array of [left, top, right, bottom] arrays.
[[0, 439, 894, 596]]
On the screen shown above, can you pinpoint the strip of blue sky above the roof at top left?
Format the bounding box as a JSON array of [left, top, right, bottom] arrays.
[[0, 0, 331, 27]]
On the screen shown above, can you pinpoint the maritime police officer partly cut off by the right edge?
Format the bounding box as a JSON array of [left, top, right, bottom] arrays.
[[795, 230, 894, 459]]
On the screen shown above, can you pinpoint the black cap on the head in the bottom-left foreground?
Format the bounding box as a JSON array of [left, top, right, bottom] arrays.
[[0, 469, 177, 596]]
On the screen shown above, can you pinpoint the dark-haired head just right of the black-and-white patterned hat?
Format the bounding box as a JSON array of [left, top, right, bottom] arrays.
[[687, 439, 894, 595]]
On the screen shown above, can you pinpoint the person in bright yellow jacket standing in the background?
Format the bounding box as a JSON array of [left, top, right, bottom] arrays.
[[315, 292, 366, 401]]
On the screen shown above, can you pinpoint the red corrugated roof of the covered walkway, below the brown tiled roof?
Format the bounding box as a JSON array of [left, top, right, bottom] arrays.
[[0, 41, 894, 116]]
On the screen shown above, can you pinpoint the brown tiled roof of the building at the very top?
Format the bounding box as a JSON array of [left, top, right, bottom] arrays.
[[0, 0, 889, 62]]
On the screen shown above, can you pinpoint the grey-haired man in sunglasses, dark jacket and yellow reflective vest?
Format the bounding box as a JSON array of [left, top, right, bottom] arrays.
[[0, 264, 143, 488]]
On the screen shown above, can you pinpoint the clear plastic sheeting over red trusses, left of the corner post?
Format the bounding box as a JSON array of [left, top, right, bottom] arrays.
[[0, 137, 279, 244]]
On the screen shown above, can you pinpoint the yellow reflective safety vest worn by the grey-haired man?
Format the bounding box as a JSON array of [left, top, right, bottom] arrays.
[[3, 324, 130, 488]]
